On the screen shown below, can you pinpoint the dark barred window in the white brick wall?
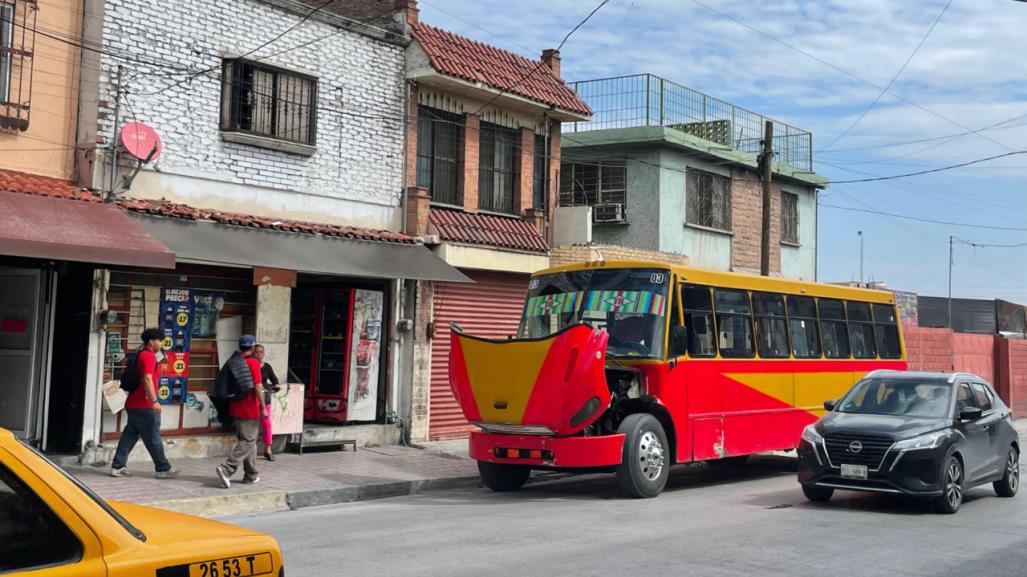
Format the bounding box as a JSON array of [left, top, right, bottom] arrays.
[[221, 60, 317, 146]]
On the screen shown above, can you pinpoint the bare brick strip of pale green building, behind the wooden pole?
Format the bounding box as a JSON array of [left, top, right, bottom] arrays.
[[731, 168, 781, 272]]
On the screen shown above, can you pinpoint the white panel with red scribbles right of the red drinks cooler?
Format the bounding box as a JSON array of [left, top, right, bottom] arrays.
[[346, 290, 385, 421]]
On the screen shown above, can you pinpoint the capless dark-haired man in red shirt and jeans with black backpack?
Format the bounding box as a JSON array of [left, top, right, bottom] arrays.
[[111, 329, 179, 478]]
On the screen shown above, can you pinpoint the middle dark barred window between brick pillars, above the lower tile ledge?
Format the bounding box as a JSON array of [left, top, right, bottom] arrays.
[[478, 122, 521, 215]]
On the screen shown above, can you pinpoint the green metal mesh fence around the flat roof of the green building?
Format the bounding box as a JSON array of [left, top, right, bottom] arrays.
[[563, 74, 813, 171]]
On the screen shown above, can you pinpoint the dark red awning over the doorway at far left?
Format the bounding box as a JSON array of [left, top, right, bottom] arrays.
[[0, 191, 175, 269]]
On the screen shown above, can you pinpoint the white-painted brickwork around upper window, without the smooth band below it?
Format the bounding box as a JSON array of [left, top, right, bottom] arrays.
[[99, 0, 405, 211]]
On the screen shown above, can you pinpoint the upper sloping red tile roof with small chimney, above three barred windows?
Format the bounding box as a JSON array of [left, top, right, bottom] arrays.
[[412, 23, 592, 116]]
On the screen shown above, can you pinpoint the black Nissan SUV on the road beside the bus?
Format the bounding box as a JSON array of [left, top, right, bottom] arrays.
[[798, 371, 1020, 513]]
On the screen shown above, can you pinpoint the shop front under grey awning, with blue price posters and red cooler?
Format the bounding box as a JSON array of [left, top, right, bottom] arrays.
[[86, 214, 467, 444]]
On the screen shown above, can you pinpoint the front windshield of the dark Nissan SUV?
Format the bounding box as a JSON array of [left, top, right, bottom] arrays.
[[835, 378, 952, 419]]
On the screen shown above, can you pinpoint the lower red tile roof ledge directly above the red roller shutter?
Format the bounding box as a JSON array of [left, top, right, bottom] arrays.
[[428, 208, 549, 253]]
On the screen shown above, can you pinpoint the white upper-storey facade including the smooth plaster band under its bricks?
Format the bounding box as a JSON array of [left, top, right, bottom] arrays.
[[86, 0, 408, 229]]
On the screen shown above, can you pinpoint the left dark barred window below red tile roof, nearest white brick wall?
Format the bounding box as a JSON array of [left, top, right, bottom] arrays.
[[417, 106, 463, 204]]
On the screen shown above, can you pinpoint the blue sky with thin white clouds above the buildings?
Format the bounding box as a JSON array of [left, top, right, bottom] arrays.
[[418, 0, 1027, 304]]
